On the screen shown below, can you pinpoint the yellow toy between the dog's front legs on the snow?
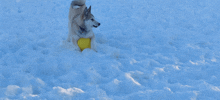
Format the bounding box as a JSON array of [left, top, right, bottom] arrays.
[[77, 38, 91, 51]]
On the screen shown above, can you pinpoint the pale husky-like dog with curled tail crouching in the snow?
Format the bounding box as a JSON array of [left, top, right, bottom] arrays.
[[67, 0, 100, 52]]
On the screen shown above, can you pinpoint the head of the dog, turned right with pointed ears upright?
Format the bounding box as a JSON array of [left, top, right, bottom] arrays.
[[82, 6, 101, 28]]
